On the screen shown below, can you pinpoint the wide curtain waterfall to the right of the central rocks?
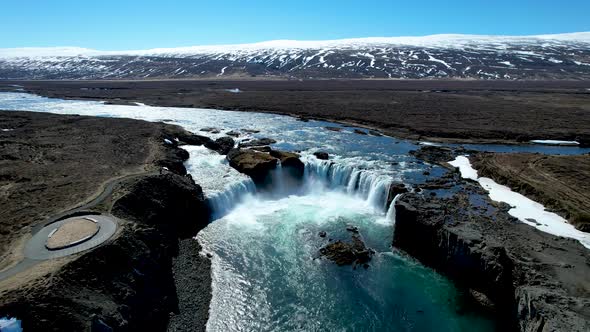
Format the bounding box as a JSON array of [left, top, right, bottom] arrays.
[[304, 159, 392, 211]]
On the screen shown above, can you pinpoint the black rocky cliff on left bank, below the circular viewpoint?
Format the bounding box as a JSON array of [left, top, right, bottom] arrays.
[[0, 173, 211, 331]]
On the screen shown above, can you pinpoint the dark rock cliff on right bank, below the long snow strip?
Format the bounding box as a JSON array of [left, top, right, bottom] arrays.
[[393, 193, 590, 331]]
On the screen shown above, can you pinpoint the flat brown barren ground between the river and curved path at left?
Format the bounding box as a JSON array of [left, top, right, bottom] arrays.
[[0, 112, 169, 269]]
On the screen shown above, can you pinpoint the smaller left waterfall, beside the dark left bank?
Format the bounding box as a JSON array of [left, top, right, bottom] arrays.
[[207, 178, 256, 220]]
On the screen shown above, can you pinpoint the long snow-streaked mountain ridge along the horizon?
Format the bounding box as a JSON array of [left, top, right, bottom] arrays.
[[0, 32, 590, 79]]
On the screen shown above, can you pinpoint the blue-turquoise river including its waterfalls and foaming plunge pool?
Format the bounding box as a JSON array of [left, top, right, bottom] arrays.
[[0, 93, 590, 331]]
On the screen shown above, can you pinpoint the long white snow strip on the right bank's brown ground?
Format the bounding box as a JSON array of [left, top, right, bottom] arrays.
[[449, 156, 590, 249]]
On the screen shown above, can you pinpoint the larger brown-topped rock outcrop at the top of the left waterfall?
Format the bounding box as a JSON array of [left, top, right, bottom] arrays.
[[227, 149, 278, 184]]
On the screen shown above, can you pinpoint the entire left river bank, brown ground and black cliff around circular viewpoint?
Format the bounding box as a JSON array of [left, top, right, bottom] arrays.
[[0, 112, 211, 331]]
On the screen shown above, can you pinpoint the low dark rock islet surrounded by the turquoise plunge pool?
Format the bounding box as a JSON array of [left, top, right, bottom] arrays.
[[320, 234, 374, 267]]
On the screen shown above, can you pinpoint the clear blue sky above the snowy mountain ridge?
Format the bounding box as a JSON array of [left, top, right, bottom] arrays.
[[0, 0, 590, 50]]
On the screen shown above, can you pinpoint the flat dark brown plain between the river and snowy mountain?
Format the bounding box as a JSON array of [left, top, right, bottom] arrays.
[[0, 80, 590, 144]]
